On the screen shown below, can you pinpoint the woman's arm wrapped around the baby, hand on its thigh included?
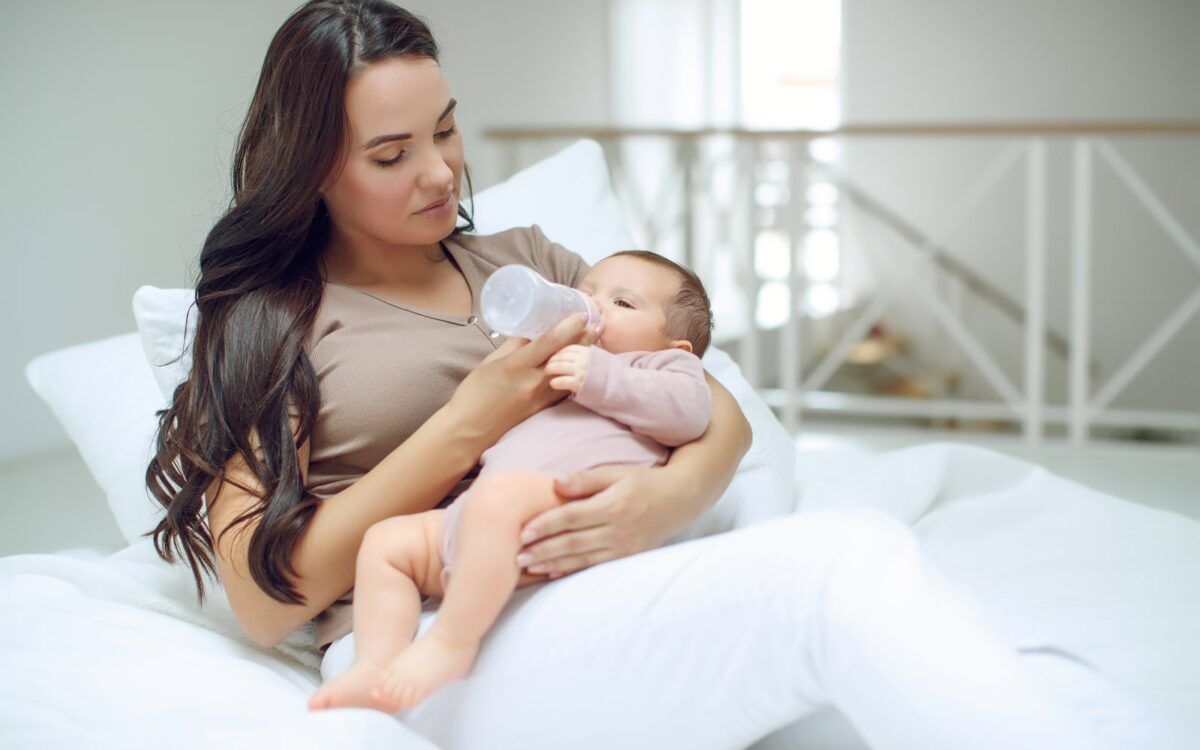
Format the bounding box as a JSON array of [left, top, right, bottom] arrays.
[[521, 372, 751, 577]]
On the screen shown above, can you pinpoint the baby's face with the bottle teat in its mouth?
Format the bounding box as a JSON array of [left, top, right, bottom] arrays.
[[578, 256, 679, 354]]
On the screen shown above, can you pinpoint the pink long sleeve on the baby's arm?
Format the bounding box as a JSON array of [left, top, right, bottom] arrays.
[[574, 346, 713, 448]]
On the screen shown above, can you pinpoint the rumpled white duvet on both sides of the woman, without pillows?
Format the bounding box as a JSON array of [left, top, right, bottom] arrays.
[[0, 444, 1200, 750]]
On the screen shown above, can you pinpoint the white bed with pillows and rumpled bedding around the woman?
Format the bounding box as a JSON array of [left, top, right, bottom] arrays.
[[0, 143, 1200, 750]]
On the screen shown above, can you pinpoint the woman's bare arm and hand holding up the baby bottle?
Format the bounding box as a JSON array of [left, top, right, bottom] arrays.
[[213, 316, 595, 647]]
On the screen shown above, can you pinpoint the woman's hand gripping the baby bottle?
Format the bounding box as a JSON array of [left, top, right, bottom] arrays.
[[446, 313, 599, 452]]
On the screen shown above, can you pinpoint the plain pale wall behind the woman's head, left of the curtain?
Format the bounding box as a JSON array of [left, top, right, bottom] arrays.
[[0, 0, 608, 460]]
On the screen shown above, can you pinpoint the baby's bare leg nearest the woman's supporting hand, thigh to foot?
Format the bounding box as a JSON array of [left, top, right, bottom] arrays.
[[374, 473, 564, 709]]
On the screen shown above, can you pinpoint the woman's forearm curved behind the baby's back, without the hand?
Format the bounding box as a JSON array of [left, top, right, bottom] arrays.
[[662, 372, 752, 535]]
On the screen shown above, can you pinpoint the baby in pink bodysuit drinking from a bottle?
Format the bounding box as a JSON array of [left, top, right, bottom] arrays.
[[308, 251, 712, 713]]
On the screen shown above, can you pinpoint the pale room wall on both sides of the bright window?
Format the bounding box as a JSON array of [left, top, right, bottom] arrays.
[[7, 0, 1200, 460]]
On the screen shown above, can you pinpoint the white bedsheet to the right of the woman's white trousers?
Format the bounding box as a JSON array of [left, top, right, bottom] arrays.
[[761, 443, 1200, 750]]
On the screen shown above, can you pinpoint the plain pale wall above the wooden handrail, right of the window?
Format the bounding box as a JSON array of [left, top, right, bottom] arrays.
[[842, 0, 1200, 122]]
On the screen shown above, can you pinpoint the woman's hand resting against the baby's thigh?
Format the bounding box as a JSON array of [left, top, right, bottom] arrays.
[[517, 464, 690, 578]]
